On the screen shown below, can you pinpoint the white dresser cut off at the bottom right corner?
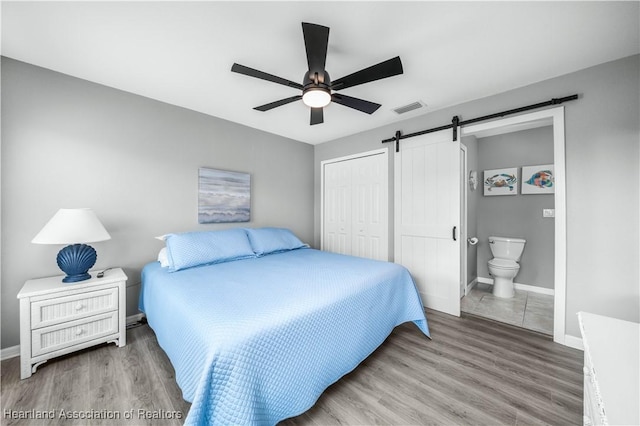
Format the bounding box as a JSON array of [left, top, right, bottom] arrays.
[[578, 312, 640, 425]]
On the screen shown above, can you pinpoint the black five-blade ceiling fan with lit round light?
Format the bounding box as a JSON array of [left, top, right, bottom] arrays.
[[231, 22, 402, 125]]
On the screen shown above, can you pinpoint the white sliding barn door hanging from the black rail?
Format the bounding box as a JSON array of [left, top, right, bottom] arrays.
[[394, 130, 460, 316]]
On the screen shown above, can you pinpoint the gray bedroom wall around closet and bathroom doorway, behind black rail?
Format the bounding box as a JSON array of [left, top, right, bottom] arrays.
[[314, 55, 640, 336]]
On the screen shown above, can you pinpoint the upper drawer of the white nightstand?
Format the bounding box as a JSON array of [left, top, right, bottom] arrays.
[[31, 287, 118, 329]]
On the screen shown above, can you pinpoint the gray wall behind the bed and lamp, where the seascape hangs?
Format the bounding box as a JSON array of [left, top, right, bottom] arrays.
[[1, 58, 313, 348]]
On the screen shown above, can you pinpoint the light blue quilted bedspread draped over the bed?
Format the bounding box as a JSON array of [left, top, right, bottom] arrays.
[[140, 249, 429, 425]]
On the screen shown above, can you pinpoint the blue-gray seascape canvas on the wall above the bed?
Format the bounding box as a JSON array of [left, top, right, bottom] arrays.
[[198, 167, 251, 223]]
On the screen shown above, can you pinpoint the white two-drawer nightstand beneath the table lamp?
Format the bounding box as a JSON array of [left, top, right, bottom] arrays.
[[18, 268, 127, 379]]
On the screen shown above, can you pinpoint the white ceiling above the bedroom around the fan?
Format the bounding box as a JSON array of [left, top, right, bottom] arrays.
[[1, 1, 640, 144]]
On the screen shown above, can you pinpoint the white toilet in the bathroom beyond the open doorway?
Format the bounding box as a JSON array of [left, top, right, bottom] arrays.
[[489, 237, 526, 298]]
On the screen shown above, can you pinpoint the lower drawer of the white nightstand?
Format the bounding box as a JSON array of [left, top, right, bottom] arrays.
[[31, 311, 119, 357]]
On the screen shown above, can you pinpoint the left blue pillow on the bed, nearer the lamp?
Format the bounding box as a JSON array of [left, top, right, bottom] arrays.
[[165, 228, 256, 272]]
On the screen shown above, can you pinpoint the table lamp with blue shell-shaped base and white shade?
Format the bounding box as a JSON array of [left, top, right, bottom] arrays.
[[31, 209, 111, 283]]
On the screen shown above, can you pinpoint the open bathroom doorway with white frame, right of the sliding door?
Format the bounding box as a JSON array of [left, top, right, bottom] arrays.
[[460, 107, 566, 343]]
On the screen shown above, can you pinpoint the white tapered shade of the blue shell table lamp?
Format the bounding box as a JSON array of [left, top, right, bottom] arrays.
[[31, 209, 111, 244]]
